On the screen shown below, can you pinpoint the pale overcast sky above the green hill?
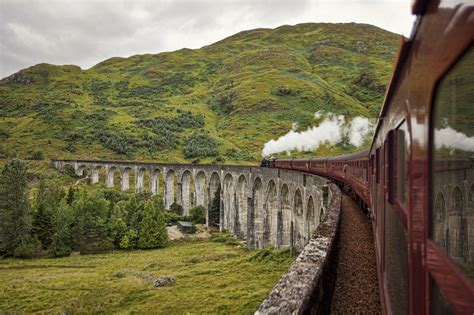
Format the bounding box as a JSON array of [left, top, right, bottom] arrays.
[[0, 0, 414, 78]]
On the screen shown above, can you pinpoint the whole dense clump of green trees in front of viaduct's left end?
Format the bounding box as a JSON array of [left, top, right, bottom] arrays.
[[0, 160, 168, 257]]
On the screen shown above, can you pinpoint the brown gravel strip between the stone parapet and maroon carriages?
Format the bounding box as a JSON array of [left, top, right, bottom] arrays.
[[331, 194, 381, 314]]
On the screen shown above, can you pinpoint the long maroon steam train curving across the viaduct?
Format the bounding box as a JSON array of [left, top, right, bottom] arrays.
[[262, 1, 474, 314]]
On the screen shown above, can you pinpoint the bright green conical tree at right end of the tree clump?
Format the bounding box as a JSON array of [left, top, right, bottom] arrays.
[[138, 202, 168, 248]]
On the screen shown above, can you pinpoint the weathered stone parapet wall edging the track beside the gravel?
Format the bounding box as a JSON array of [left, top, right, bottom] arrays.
[[255, 184, 341, 314]]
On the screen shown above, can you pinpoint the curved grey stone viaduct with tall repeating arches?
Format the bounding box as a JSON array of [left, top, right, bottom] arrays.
[[53, 160, 331, 249]]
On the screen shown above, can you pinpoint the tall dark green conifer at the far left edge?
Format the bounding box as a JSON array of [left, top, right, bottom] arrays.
[[0, 159, 34, 256]]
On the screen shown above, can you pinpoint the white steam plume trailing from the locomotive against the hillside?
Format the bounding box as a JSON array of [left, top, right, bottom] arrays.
[[262, 112, 374, 156]]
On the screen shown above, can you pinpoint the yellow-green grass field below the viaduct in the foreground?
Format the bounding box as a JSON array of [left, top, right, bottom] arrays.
[[0, 241, 292, 314]]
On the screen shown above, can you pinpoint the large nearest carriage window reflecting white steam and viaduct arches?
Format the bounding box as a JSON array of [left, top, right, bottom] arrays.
[[430, 47, 474, 279]]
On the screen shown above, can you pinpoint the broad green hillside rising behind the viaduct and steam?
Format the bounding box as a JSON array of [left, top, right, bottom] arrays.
[[0, 23, 398, 163]]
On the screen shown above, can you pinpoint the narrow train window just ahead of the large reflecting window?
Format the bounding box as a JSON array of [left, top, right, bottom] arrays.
[[395, 122, 408, 205]]
